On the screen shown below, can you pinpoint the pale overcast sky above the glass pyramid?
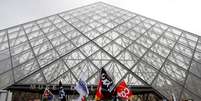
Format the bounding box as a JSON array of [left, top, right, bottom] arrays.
[[0, 0, 201, 35]]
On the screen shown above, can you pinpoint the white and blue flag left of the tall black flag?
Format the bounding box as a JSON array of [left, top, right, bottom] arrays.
[[75, 79, 89, 101]]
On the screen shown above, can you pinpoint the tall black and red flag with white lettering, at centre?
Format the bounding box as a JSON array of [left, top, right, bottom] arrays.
[[95, 68, 114, 100]]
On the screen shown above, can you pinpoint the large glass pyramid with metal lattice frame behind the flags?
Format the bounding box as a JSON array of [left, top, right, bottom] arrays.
[[0, 2, 201, 101]]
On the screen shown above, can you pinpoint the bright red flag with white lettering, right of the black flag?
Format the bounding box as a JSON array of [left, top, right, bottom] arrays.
[[116, 80, 133, 99]]
